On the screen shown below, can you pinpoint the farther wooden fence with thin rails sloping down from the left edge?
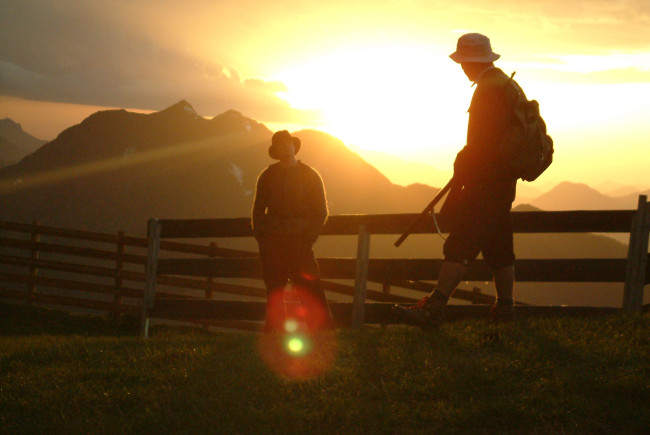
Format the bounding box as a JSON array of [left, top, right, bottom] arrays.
[[0, 221, 430, 330]]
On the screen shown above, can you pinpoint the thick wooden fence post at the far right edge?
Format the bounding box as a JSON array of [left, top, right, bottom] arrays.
[[623, 195, 650, 313]]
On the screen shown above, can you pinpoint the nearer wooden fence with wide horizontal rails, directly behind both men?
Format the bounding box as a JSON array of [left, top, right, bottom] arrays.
[[141, 196, 650, 336]]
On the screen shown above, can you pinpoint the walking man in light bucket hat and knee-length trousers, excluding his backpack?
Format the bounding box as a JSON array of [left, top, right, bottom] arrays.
[[394, 33, 518, 328]]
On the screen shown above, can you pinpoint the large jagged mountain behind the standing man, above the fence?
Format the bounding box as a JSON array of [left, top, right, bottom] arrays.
[[0, 101, 437, 234]]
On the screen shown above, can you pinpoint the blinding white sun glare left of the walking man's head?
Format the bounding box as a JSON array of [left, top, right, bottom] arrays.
[[279, 44, 471, 160]]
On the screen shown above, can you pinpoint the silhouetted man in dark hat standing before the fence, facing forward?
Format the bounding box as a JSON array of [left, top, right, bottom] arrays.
[[252, 130, 333, 332]]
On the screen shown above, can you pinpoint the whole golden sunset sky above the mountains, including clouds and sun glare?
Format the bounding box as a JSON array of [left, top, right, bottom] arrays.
[[0, 0, 650, 189]]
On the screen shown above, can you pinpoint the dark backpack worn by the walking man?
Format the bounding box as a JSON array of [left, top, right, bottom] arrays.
[[500, 73, 554, 181]]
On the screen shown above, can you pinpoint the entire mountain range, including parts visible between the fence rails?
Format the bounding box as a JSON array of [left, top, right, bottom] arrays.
[[0, 101, 649, 305]]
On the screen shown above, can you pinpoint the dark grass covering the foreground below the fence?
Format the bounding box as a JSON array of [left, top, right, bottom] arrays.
[[0, 305, 650, 434]]
